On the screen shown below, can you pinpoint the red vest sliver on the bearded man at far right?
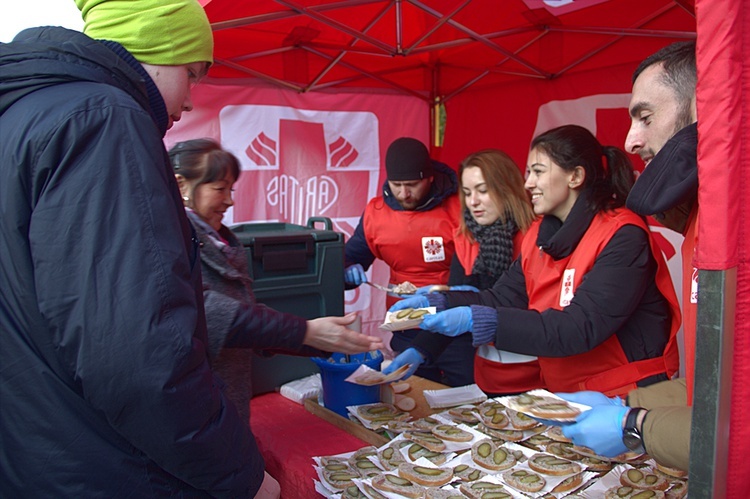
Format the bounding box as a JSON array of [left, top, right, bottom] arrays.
[[682, 203, 698, 405]]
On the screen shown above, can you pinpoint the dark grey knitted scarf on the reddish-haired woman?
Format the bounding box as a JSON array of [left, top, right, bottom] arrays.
[[464, 209, 518, 282]]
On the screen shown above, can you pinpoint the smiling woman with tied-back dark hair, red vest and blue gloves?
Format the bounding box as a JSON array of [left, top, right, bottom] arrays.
[[392, 125, 680, 395]]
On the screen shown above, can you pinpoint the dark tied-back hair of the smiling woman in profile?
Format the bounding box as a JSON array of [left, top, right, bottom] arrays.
[[531, 125, 635, 212]]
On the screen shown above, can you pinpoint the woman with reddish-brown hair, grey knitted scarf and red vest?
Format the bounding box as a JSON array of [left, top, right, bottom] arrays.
[[384, 149, 541, 394]]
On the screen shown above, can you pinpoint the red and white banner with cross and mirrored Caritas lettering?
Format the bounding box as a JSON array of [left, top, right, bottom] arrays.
[[165, 82, 429, 348]]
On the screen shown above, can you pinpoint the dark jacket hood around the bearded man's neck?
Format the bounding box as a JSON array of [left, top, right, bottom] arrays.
[[626, 123, 698, 221]]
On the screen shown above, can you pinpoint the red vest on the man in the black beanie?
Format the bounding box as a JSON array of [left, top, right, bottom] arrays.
[[364, 194, 459, 307]]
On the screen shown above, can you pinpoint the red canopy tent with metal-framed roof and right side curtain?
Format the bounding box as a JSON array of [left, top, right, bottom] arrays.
[[182, 0, 750, 497]]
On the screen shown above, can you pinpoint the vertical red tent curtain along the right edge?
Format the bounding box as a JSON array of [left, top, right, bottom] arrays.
[[694, 0, 750, 498]]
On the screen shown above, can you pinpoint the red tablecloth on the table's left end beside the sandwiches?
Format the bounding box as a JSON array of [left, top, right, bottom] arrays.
[[250, 393, 369, 499]]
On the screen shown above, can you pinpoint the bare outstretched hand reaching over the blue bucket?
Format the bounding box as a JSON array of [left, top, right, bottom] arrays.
[[303, 312, 385, 354]]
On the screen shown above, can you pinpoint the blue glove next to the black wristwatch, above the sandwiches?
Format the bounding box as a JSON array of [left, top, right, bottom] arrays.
[[562, 405, 630, 457]]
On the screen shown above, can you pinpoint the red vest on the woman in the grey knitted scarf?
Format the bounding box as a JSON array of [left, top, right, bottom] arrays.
[[455, 231, 544, 393]]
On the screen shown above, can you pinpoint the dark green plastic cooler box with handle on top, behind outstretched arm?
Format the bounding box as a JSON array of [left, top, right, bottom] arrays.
[[231, 217, 344, 395]]
